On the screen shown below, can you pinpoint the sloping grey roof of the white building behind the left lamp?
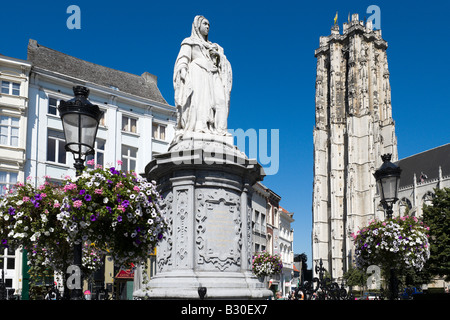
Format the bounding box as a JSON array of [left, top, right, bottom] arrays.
[[28, 39, 167, 104]]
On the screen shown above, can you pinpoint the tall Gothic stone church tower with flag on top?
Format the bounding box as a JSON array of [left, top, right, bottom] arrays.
[[312, 14, 398, 279]]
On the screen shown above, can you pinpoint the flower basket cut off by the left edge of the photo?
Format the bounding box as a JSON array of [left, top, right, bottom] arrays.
[[0, 177, 79, 276]]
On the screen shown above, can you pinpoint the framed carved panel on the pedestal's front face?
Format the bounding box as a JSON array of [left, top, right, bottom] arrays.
[[195, 188, 242, 271]]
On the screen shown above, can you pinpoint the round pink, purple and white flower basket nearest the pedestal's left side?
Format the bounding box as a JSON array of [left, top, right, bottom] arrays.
[[57, 167, 167, 264]]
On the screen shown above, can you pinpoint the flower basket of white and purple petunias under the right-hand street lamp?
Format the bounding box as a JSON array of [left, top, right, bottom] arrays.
[[352, 216, 430, 271]]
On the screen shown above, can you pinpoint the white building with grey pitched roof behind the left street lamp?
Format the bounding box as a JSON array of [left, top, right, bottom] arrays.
[[25, 40, 176, 184]]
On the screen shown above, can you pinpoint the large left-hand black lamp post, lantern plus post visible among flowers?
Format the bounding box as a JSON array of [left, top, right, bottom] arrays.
[[58, 86, 103, 300]]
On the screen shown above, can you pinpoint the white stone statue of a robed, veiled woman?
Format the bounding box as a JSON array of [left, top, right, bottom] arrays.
[[173, 16, 232, 140]]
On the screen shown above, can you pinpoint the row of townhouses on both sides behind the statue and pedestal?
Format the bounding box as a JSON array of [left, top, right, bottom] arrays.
[[0, 40, 293, 297]]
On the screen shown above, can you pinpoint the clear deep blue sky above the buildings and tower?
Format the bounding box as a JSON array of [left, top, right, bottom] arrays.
[[0, 0, 450, 267]]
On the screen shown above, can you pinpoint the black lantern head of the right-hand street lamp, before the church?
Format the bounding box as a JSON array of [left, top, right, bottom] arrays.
[[374, 153, 402, 219]]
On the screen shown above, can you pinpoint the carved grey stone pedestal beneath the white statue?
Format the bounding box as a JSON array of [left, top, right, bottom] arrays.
[[134, 133, 272, 299]]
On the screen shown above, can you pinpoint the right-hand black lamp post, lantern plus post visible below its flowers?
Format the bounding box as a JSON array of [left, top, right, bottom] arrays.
[[374, 153, 402, 300]]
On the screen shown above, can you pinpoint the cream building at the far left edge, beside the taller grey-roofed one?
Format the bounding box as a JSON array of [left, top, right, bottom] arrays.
[[0, 55, 31, 294]]
